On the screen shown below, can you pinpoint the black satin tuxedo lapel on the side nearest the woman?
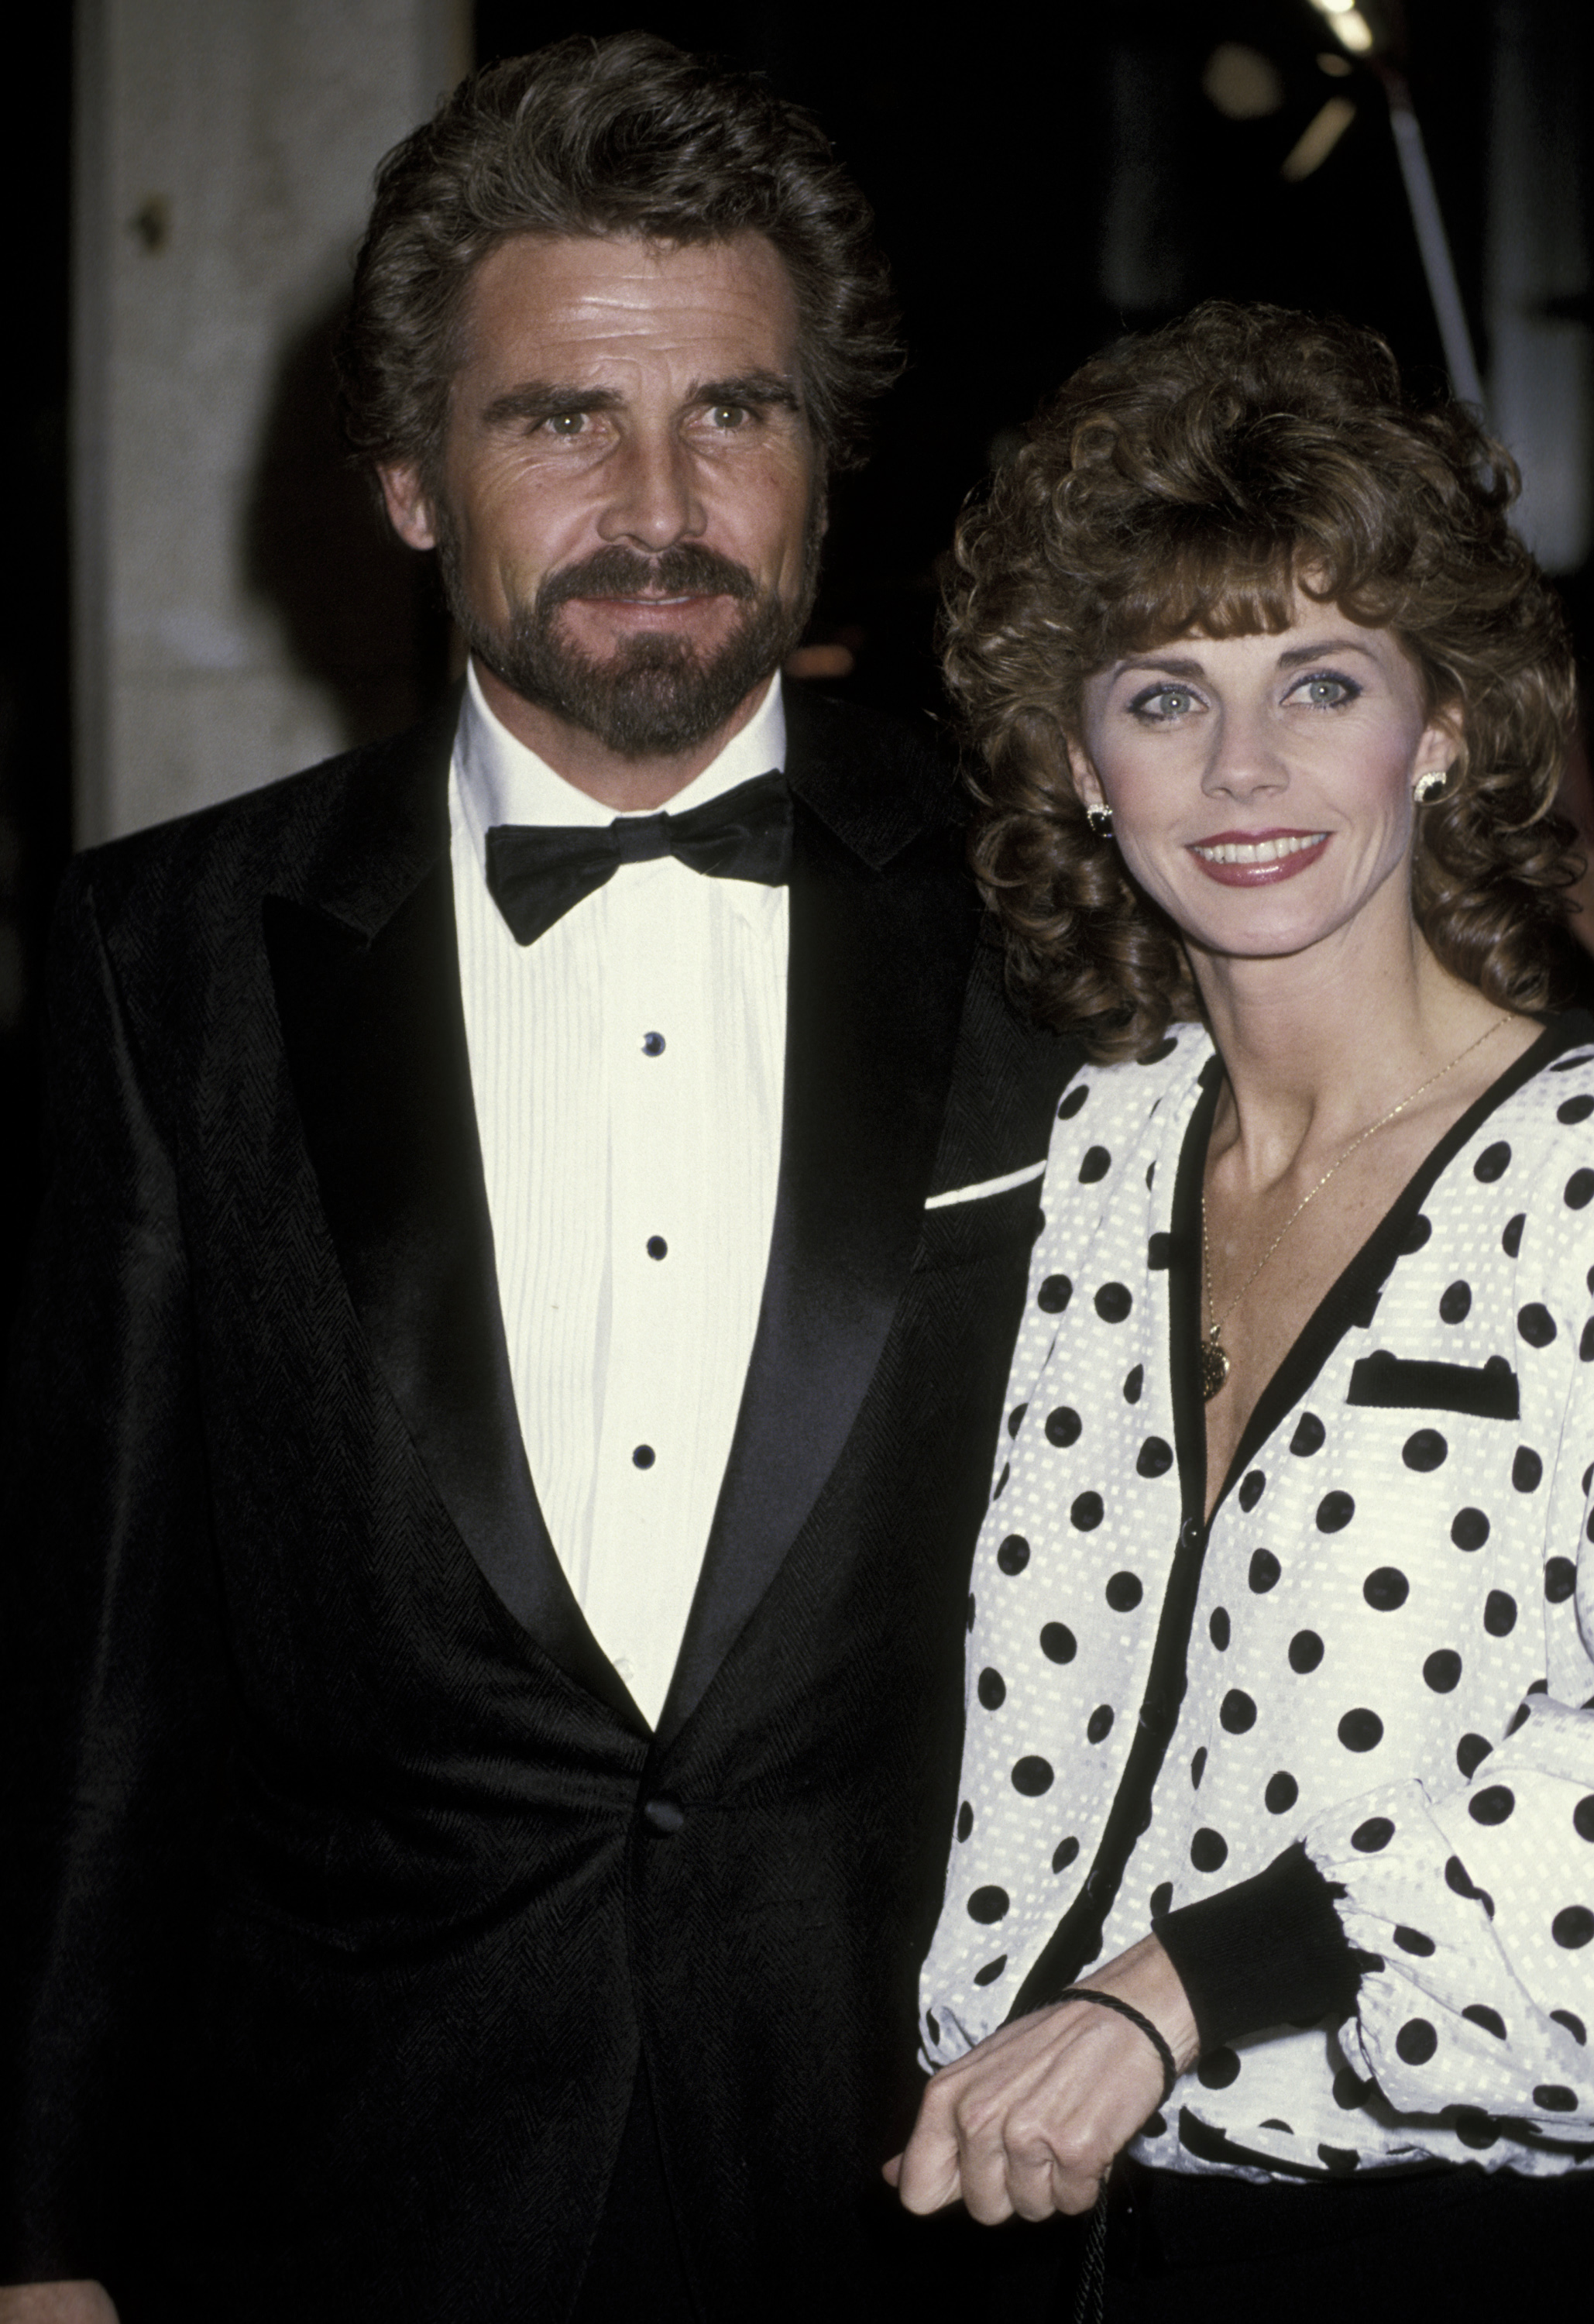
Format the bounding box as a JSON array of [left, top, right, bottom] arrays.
[[658, 744, 976, 1738]]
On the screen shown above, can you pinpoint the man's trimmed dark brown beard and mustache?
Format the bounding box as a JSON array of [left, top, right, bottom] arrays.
[[437, 502, 823, 758]]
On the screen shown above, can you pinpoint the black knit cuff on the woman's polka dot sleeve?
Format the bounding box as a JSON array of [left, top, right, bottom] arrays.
[[1153, 1843, 1383, 2050]]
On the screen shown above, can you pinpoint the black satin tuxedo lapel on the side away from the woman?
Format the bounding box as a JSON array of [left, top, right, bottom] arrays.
[[265, 744, 646, 1731]]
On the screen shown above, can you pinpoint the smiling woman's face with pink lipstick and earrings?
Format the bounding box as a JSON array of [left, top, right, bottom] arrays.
[[1071, 600, 1457, 960]]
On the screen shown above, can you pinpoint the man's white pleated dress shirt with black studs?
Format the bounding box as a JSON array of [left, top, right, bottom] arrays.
[[448, 667, 788, 1722]]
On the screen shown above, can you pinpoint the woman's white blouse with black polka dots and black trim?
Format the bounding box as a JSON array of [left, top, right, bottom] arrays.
[[922, 1016, 1594, 2180]]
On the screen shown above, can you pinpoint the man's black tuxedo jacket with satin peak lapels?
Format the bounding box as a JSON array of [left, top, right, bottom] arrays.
[[0, 695, 1071, 2324]]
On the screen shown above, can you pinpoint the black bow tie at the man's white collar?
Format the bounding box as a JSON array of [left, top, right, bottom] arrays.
[[488, 774, 792, 944]]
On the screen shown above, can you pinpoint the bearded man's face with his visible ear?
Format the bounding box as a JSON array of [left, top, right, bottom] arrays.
[[383, 235, 823, 758]]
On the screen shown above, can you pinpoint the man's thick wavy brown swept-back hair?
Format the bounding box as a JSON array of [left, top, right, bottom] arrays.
[[337, 33, 899, 483]]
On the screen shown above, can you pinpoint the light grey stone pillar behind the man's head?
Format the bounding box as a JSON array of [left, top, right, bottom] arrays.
[[72, 0, 469, 844]]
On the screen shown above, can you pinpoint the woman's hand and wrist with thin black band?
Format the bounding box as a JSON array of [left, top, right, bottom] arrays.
[[885, 1936, 1199, 2226]]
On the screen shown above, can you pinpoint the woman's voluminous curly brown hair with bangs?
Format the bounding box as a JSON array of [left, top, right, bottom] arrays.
[[943, 302, 1580, 1060]]
